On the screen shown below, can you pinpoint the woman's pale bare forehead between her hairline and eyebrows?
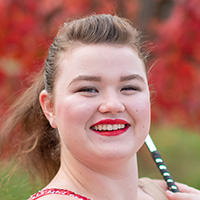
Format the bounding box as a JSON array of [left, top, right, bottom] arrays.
[[59, 44, 146, 80]]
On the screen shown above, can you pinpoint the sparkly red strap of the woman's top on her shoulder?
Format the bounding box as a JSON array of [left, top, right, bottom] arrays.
[[28, 188, 91, 200]]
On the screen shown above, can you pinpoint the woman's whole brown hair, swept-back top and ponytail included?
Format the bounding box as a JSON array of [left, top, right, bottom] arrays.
[[0, 14, 146, 182]]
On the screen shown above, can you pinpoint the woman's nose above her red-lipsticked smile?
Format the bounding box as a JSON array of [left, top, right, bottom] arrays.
[[99, 94, 125, 114]]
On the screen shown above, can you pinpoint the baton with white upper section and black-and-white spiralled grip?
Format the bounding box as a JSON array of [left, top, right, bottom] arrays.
[[145, 134, 179, 192]]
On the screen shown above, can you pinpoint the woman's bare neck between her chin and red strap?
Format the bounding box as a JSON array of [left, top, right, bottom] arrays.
[[48, 150, 138, 200]]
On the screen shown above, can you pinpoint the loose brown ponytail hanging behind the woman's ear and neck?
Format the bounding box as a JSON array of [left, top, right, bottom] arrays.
[[0, 69, 60, 182]]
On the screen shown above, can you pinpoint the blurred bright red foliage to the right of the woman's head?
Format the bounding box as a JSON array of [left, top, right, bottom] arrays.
[[150, 0, 200, 129]]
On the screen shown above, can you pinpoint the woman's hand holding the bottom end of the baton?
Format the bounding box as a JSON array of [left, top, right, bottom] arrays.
[[166, 183, 200, 200]]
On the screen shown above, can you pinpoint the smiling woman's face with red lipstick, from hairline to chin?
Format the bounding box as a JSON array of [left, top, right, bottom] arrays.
[[48, 45, 150, 167]]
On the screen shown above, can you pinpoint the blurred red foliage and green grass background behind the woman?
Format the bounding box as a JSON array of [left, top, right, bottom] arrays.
[[0, 0, 200, 200]]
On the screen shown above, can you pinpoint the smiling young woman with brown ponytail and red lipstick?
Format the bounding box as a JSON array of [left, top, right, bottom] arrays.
[[0, 15, 200, 200]]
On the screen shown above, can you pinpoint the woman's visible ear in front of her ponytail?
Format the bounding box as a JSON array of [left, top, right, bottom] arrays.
[[39, 90, 57, 128]]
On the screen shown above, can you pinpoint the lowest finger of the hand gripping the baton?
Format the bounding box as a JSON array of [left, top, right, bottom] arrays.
[[166, 190, 199, 200]]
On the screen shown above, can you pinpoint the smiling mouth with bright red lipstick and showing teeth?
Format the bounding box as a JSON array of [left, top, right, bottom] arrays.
[[91, 119, 130, 136]]
